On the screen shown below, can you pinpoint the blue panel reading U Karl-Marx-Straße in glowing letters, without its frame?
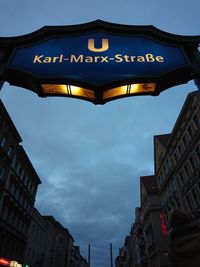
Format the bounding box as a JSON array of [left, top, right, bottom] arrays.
[[8, 31, 189, 86]]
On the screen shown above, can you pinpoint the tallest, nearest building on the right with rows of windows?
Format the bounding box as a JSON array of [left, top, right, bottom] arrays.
[[154, 91, 200, 227]]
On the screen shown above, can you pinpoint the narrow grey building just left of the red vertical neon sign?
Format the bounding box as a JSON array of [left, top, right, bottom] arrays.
[[140, 175, 168, 267]]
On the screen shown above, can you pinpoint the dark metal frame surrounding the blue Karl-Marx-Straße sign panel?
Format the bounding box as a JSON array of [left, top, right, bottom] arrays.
[[0, 20, 200, 104]]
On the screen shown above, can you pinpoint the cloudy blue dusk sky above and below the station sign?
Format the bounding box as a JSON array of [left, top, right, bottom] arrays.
[[0, 0, 200, 267]]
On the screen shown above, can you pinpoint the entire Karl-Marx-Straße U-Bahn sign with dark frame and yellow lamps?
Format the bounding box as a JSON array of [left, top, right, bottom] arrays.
[[0, 20, 200, 104]]
